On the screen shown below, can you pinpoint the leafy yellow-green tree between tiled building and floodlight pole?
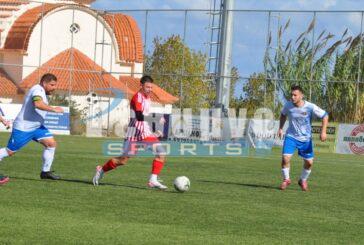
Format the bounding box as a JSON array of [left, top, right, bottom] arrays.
[[146, 35, 214, 110]]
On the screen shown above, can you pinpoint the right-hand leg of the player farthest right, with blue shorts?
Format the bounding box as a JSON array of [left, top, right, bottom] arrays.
[[298, 140, 314, 191]]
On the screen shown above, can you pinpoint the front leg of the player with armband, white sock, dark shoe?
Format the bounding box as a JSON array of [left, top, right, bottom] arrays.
[[33, 127, 60, 180]]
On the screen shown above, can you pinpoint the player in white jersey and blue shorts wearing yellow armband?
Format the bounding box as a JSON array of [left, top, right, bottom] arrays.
[[0, 73, 63, 184]]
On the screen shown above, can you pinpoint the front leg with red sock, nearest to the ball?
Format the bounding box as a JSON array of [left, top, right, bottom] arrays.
[[147, 138, 168, 190]]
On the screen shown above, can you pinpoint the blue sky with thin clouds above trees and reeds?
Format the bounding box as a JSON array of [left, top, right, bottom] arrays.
[[92, 0, 364, 96]]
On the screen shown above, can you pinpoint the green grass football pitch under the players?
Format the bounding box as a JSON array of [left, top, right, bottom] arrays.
[[0, 134, 364, 244]]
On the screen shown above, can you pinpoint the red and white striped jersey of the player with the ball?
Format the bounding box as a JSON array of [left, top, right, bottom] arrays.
[[126, 91, 153, 141]]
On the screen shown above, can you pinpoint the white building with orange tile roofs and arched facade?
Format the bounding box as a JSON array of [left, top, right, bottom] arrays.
[[0, 0, 178, 137]]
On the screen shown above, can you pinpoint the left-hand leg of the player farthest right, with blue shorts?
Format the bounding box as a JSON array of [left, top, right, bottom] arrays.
[[280, 137, 297, 190]]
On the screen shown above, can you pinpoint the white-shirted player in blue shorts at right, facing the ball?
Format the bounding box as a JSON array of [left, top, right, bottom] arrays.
[[278, 86, 329, 191]]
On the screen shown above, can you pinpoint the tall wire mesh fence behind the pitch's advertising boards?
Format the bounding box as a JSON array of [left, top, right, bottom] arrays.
[[0, 1, 364, 136]]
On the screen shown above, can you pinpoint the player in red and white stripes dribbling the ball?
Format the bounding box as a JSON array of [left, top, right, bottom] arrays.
[[93, 76, 167, 190]]
